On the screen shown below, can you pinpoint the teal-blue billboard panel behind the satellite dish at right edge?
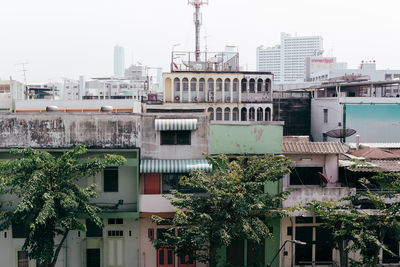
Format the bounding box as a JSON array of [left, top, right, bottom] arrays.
[[345, 104, 400, 143]]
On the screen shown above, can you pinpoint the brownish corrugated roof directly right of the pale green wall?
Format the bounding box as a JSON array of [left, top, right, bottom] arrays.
[[282, 142, 345, 154]]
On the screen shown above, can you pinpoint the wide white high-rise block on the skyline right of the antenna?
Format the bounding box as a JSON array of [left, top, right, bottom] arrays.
[[257, 33, 322, 84]]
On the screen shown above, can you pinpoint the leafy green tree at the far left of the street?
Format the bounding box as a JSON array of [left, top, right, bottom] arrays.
[[0, 145, 125, 267]]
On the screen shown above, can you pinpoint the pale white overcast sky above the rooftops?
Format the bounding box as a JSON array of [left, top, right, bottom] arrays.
[[0, 0, 400, 83]]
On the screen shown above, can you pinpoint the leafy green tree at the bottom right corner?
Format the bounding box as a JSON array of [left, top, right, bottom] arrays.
[[306, 172, 400, 266]]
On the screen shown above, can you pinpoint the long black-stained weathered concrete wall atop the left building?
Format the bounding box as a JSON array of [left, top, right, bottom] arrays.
[[0, 113, 141, 148]]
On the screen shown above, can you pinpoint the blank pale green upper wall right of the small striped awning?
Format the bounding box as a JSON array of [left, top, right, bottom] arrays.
[[209, 124, 283, 154]]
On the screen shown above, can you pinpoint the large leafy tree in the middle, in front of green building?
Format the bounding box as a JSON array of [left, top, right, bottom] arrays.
[[152, 155, 290, 266]]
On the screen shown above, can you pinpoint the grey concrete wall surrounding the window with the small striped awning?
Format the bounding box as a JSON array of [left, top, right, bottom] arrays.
[[141, 113, 209, 159]]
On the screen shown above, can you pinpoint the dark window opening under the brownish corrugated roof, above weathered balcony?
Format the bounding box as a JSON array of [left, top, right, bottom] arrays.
[[290, 167, 323, 185]]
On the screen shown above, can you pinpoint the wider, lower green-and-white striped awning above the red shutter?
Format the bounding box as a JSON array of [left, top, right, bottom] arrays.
[[140, 159, 212, 173]]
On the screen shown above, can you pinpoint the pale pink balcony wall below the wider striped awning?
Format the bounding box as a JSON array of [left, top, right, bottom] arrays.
[[139, 194, 175, 213]]
